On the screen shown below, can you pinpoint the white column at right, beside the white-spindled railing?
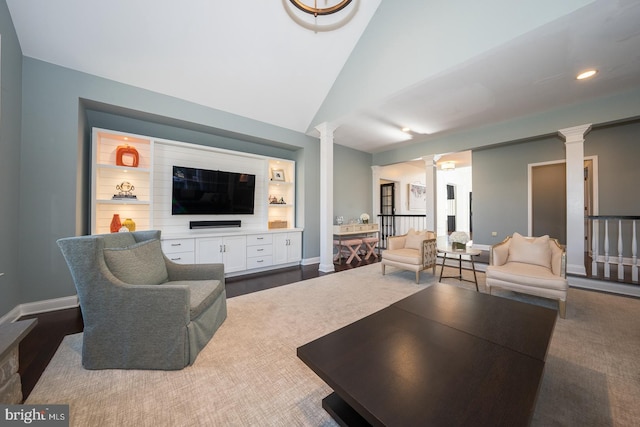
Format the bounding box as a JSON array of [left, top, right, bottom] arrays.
[[558, 124, 591, 276]]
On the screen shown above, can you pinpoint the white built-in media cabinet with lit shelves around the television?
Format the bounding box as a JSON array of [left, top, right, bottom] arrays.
[[91, 128, 303, 275]]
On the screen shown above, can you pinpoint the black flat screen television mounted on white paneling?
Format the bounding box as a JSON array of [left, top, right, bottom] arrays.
[[171, 166, 256, 215]]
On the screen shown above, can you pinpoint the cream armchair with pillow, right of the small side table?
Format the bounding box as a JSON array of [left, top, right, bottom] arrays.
[[486, 233, 569, 318]]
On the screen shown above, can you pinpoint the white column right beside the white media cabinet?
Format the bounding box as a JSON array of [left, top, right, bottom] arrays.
[[316, 122, 335, 273]]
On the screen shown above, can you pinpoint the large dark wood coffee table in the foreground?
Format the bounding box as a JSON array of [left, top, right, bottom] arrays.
[[297, 284, 557, 426]]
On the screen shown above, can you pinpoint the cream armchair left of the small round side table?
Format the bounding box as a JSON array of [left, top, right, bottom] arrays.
[[381, 229, 438, 283]]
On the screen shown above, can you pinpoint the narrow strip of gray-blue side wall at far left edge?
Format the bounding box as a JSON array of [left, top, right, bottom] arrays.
[[0, 0, 23, 317]]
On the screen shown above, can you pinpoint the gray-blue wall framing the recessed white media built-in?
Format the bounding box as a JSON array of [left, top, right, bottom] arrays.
[[16, 58, 320, 311]]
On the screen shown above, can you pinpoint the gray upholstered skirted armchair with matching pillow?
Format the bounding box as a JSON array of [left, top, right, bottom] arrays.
[[58, 231, 227, 370]]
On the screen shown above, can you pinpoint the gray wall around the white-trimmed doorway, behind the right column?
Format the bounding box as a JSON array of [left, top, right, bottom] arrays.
[[473, 120, 640, 244]]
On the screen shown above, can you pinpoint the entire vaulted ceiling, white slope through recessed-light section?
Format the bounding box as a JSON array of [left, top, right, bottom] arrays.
[[7, 0, 640, 153]]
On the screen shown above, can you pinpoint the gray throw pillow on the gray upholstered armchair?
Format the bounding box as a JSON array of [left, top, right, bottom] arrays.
[[103, 239, 169, 285]]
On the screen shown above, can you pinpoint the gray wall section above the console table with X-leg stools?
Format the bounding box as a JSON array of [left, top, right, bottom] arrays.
[[333, 144, 377, 221]]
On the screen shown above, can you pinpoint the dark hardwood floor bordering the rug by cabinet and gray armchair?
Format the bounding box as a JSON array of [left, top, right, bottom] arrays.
[[18, 259, 378, 399]]
